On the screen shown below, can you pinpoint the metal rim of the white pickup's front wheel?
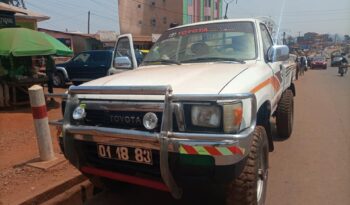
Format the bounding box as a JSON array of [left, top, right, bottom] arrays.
[[256, 147, 268, 204]]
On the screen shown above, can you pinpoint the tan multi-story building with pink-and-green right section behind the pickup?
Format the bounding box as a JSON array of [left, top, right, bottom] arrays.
[[118, 0, 222, 48]]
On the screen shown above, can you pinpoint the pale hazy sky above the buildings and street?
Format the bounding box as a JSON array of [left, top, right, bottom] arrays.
[[25, 0, 350, 36]]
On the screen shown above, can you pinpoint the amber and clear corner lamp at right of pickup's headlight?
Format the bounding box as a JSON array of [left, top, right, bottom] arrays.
[[223, 102, 243, 133]]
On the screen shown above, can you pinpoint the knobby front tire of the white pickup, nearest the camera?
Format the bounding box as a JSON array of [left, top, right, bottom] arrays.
[[226, 126, 269, 205]]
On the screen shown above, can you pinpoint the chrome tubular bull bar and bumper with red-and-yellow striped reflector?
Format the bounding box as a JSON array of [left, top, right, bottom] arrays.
[[51, 86, 257, 198]]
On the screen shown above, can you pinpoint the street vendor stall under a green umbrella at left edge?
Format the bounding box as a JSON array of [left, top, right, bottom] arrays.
[[0, 28, 73, 107]]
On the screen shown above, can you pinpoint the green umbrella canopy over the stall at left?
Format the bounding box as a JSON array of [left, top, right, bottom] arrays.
[[0, 28, 73, 56]]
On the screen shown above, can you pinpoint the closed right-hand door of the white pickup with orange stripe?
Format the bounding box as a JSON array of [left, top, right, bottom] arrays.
[[260, 24, 284, 100]]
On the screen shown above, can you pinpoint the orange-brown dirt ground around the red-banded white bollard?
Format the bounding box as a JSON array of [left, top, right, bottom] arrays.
[[0, 89, 78, 204]]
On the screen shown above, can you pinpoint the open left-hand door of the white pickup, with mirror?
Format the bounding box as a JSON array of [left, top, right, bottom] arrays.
[[109, 34, 138, 74]]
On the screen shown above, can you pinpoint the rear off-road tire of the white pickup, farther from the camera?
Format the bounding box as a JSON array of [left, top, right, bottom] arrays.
[[276, 89, 294, 139]]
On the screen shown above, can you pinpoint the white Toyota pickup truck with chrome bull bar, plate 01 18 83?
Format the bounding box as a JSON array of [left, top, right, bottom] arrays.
[[55, 19, 295, 204]]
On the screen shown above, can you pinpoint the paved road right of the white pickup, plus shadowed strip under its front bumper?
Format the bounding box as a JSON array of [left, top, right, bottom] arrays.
[[83, 67, 350, 205]]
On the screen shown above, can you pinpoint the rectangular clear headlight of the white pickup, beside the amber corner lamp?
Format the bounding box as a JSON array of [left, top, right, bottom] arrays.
[[191, 105, 221, 128]]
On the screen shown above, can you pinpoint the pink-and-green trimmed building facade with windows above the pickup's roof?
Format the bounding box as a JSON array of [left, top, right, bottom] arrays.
[[182, 0, 222, 24]]
